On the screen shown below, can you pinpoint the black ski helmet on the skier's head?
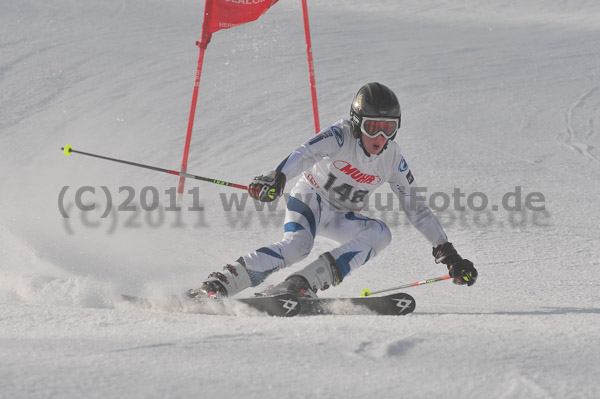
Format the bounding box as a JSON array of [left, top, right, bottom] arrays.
[[350, 82, 402, 142]]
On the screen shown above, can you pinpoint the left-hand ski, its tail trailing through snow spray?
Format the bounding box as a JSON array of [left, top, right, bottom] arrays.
[[121, 294, 301, 317]]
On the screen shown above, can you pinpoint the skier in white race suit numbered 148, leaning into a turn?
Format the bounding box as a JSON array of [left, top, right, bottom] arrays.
[[187, 83, 477, 298]]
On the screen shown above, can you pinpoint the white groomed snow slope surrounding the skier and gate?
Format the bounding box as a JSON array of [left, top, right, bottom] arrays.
[[0, 0, 600, 399]]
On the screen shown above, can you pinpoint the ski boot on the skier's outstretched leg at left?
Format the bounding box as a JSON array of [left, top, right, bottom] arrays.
[[185, 257, 251, 299]]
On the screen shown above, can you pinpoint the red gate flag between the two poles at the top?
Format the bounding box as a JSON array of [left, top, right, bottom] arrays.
[[201, 0, 278, 48]]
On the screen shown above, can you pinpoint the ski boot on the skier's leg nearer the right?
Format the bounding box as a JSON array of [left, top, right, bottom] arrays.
[[257, 252, 342, 299]]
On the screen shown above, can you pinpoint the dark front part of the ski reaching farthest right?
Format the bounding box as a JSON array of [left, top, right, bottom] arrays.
[[300, 293, 416, 316]]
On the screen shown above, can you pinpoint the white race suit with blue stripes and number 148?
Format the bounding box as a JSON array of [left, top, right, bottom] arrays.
[[243, 119, 447, 286]]
